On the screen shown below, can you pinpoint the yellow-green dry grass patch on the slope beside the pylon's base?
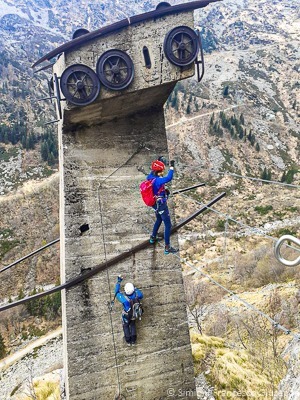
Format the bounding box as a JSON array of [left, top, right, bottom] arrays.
[[191, 331, 285, 400]]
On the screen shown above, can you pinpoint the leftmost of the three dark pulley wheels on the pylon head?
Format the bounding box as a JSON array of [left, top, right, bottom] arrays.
[[60, 64, 100, 106]]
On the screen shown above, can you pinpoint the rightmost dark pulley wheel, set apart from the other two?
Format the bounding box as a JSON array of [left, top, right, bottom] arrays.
[[164, 26, 199, 67]]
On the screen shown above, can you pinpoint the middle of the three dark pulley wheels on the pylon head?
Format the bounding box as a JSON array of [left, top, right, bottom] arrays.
[[96, 50, 134, 90]]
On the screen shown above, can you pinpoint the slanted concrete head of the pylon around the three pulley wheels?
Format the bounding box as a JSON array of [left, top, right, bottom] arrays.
[[55, 12, 195, 125]]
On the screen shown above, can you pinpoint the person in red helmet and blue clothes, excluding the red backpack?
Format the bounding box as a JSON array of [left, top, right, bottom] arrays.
[[147, 157, 178, 254]]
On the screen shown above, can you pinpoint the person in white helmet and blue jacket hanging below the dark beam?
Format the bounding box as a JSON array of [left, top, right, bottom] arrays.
[[115, 276, 144, 346]]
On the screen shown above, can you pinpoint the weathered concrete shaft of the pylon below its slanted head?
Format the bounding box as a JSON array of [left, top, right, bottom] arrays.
[[62, 110, 194, 400]]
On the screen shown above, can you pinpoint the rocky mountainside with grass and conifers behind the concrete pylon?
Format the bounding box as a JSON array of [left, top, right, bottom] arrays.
[[0, 0, 300, 400]]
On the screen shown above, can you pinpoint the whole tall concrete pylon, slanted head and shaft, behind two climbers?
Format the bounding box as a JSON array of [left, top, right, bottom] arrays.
[[53, 2, 208, 400]]
